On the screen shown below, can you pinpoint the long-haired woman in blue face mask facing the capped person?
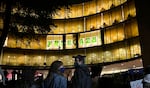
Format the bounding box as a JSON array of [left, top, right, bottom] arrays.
[[42, 61, 67, 88]]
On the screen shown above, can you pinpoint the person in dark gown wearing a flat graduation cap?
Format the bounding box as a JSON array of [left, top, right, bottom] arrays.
[[72, 55, 92, 88]]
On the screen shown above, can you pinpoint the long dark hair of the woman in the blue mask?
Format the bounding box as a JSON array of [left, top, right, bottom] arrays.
[[47, 61, 63, 77]]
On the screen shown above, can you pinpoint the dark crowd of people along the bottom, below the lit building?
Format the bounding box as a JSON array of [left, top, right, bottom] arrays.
[[0, 55, 150, 88]]
